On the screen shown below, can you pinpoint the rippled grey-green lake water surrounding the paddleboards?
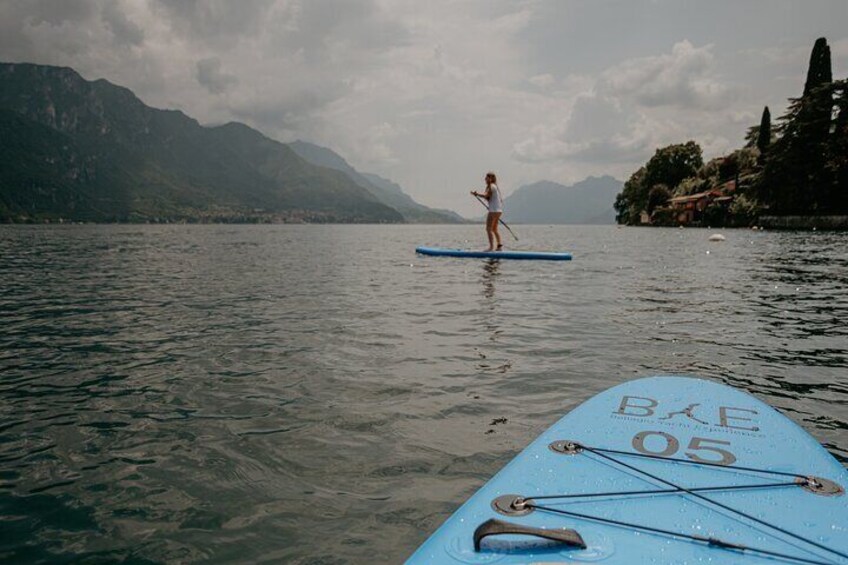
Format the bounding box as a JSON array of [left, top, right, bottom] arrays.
[[0, 225, 848, 564]]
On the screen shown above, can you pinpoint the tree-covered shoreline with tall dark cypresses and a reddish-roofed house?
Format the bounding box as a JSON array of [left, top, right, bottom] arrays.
[[615, 38, 848, 227]]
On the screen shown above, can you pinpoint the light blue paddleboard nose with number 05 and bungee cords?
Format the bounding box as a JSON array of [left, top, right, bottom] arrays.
[[407, 377, 848, 565]]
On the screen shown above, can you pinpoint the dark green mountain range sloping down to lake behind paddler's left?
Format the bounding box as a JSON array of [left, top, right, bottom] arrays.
[[0, 63, 461, 223]]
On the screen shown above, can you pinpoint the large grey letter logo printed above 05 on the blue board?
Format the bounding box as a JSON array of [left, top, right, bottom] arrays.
[[613, 396, 760, 432]]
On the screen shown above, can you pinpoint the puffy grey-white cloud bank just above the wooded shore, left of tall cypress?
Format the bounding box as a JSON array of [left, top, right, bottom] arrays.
[[513, 41, 744, 166]]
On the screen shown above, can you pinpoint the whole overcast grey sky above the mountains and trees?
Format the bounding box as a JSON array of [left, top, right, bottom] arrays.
[[0, 0, 848, 215]]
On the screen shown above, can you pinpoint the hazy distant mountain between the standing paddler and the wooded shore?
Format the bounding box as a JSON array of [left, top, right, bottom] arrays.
[[504, 176, 622, 224]]
